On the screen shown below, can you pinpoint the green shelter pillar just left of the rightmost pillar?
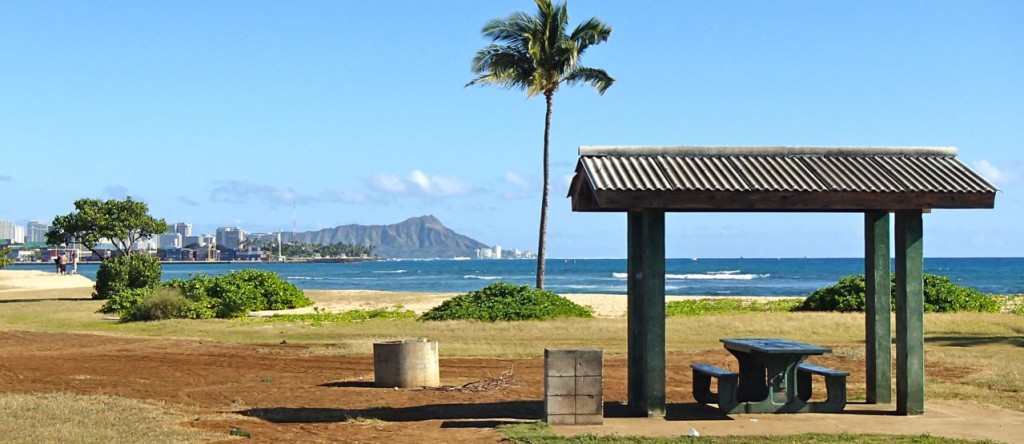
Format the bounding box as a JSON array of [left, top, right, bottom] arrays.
[[864, 212, 893, 404]]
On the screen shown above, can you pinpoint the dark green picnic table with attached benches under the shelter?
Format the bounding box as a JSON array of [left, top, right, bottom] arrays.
[[691, 339, 849, 413]]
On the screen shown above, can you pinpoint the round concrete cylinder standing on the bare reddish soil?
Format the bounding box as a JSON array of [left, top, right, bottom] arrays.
[[374, 339, 440, 388]]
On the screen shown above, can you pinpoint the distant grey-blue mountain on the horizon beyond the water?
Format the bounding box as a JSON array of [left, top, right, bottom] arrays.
[[282, 215, 488, 259]]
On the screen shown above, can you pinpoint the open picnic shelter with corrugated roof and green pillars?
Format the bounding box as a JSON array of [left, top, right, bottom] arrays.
[[568, 146, 996, 416]]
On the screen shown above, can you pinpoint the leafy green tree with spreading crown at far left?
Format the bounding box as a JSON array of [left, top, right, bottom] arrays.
[[46, 196, 167, 255]]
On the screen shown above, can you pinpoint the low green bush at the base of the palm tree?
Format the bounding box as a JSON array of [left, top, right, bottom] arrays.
[[420, 282, 593, 322]]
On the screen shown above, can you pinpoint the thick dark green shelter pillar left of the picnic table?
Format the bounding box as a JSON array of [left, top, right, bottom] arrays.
[[627, 210, 665, 416]]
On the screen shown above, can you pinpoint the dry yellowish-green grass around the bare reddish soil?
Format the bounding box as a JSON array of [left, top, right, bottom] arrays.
[[0, 290, 1024, 442]]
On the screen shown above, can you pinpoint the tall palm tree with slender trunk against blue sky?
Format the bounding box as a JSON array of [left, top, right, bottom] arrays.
[[466, 0, 615, 290]]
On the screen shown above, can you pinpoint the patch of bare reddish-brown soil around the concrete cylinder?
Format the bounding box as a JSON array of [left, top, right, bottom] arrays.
[[0, 331, 964, 443]]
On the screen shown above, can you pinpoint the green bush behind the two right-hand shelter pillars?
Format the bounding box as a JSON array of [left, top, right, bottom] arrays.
[[798, 274, 1001, 313]]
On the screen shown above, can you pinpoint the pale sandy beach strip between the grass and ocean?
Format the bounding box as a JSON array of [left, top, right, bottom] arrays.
[[0, 270, 798, 317]]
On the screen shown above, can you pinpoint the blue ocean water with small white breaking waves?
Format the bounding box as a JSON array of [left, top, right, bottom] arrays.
[[14, 258, 1024, 296]]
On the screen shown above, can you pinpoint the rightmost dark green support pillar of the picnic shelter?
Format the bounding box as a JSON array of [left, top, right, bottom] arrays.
[[896, 210, 925, 415]]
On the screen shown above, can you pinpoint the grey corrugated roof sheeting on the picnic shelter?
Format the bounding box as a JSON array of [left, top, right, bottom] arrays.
[[581, 147, 995, 192]]
